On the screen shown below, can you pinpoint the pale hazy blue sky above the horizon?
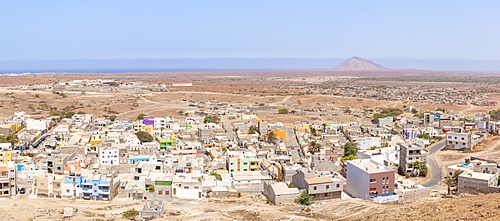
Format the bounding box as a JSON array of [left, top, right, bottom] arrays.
[[0, 0, 500, 60]]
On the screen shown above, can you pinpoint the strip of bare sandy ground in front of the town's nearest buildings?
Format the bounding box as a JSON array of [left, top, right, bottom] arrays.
[[0, 191, 500, 220]]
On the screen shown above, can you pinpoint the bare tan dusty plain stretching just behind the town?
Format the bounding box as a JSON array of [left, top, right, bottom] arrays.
[[0, 88, 497, 126]]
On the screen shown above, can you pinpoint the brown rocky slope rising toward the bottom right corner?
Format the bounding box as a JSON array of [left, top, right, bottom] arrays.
[[312, 194, 500, 221]]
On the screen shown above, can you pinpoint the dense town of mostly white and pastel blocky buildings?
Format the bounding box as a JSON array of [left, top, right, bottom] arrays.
[[0, 80, 500, 219]]
